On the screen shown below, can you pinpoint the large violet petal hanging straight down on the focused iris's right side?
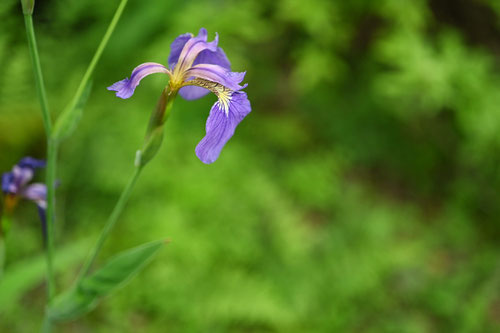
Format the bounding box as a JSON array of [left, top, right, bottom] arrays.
[[195, 91, 251, 164]]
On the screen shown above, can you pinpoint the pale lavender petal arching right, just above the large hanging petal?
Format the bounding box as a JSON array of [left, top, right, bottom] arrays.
[[187, 64, 246, 90]]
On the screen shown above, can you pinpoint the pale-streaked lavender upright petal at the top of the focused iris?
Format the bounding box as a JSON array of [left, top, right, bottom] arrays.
[[175, 28, 219, 74]]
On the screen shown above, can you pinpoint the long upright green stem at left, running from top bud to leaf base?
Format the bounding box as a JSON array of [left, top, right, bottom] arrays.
[[24, 14, 57, 303]]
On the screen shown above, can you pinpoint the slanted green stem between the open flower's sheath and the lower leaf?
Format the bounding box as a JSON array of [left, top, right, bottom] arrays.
[[76, 167, 142, 285]]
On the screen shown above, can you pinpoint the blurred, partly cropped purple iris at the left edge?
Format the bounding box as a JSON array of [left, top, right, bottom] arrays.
[[2, 157, 47, 224]]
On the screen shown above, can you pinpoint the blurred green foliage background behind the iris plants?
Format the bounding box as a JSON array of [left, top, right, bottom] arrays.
[[0, 0, 500, 333]]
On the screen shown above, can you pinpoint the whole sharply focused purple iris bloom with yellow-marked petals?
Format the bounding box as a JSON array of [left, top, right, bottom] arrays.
[[108, 28, 251, 164]]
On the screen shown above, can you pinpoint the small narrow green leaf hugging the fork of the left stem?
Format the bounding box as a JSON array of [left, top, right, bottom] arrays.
[[53, 81, 92, 141]]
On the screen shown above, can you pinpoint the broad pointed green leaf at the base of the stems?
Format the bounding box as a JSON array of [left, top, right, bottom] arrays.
[[49, 240, 165, 321]]
